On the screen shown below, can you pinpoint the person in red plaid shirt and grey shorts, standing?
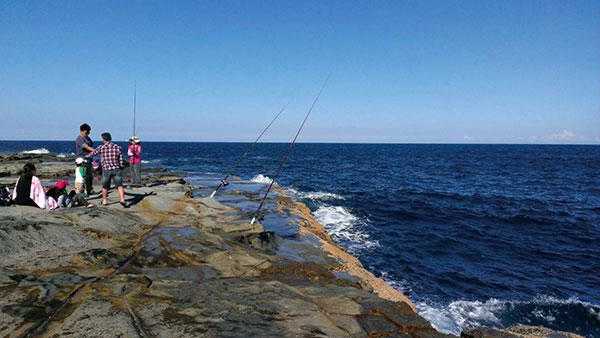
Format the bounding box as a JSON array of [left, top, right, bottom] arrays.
[[87, 133, 127, 208]]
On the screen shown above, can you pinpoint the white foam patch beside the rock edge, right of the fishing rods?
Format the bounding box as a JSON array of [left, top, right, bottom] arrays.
[[313, 205, 379, 251]]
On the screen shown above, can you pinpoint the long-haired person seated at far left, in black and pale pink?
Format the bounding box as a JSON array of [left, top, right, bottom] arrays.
[[12, 163, 46, 209]]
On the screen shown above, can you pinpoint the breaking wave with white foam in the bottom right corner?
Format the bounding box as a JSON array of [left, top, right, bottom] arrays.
[[416, 296, 600, 337]]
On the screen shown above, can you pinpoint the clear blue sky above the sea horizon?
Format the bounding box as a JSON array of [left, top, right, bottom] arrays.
[[0, 0, 600, 143]]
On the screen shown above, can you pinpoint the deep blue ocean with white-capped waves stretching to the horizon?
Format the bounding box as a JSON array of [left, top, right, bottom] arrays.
[[0, 141, 600, 337]]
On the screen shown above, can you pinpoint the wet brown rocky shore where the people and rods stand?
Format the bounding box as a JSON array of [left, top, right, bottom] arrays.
[[0, 155, 575, 337]]
